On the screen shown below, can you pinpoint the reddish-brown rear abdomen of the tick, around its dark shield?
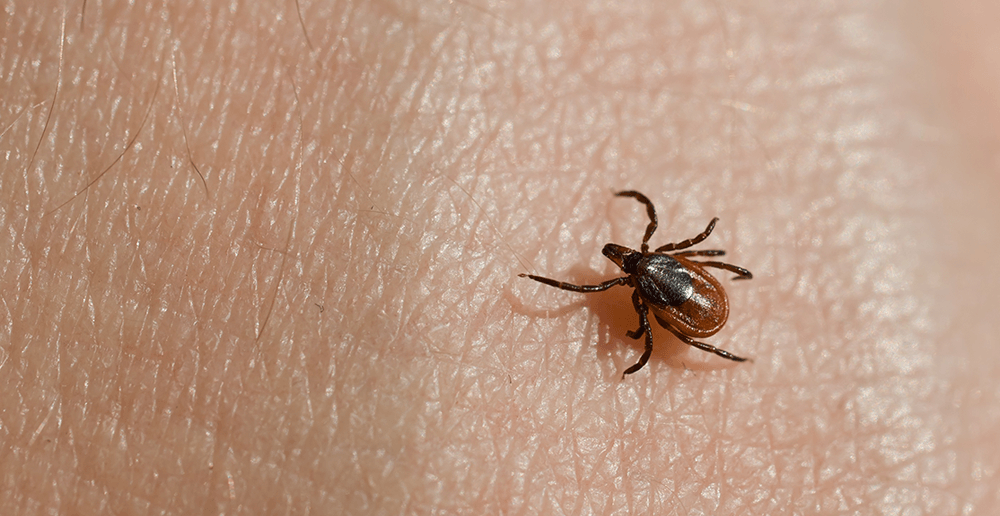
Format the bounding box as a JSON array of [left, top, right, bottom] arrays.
[[648, 256, 729, 338]]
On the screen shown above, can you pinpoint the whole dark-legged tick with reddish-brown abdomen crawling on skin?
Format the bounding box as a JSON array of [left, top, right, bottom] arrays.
[[519, 190, 753, 379]]
